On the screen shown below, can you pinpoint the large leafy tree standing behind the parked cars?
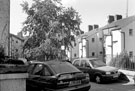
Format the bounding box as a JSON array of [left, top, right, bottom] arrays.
[[21, 0, 82, 59]]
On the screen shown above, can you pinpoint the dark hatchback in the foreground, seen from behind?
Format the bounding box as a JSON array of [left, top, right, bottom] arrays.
[[26, 61, 91, 91]]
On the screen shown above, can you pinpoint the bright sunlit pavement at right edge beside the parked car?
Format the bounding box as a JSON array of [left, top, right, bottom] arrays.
[[119, 69, 135, 85]]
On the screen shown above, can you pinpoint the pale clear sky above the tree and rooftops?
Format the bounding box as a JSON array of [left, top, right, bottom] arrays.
[[10, 0, 135, 34]]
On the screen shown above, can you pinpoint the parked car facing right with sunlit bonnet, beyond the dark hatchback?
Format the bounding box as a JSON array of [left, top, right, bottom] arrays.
[[72, 58, 120, 83]]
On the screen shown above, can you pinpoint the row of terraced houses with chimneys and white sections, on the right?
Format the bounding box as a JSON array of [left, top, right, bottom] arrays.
[[70, 15, 135, 67]]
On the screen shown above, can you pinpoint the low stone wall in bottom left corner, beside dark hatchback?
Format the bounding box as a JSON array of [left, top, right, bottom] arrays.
[[0, 73, 28, 91]]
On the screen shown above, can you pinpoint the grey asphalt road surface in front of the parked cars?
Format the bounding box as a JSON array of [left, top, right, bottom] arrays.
[[89, 80, 135, 91]]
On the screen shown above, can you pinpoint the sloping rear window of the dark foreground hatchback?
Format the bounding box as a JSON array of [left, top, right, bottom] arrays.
[[50, 62, 80, 74]]
